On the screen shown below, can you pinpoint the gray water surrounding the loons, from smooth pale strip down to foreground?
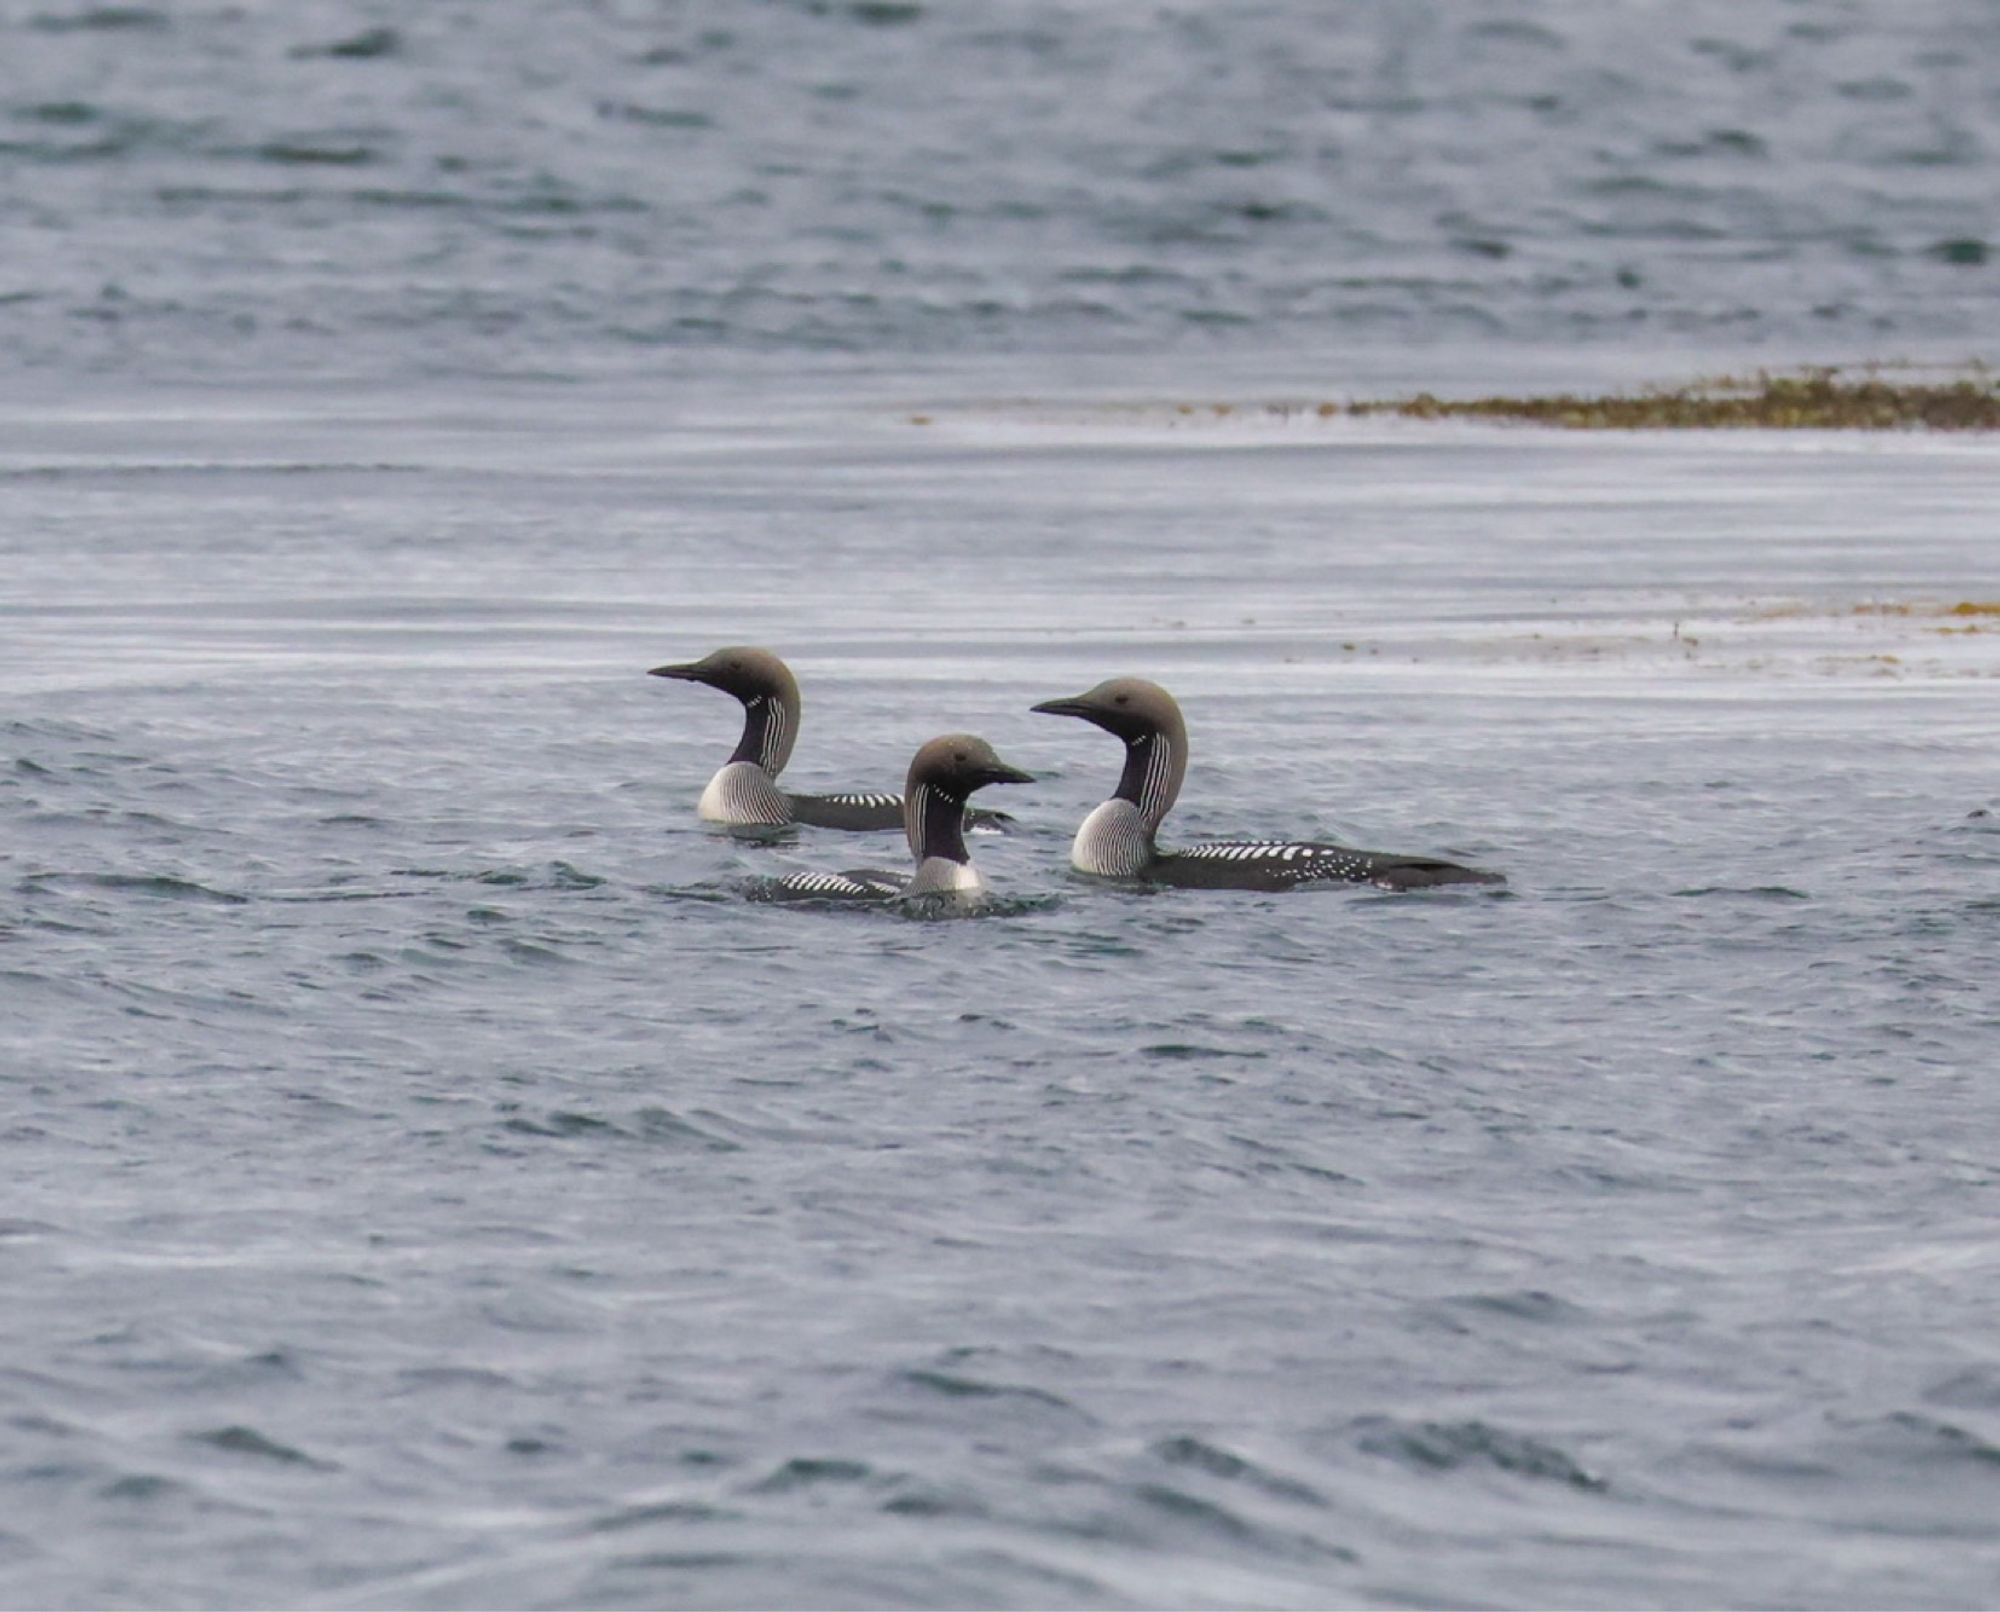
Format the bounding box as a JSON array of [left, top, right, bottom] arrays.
[[0, 372, 2000, 1606]]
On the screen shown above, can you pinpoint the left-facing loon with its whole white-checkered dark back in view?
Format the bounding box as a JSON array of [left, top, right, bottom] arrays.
[[1034, 678, 1506, 890]]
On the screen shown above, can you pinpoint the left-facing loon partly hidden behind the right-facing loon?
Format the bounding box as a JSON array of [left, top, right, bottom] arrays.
[[646, 644, 1012, 832]]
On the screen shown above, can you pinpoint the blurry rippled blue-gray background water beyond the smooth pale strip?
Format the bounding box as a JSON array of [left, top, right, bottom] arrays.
[[0, 0, 2000, 374]]
